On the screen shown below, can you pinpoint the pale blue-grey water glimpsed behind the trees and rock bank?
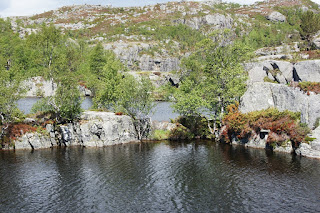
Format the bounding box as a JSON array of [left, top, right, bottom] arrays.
[[17, 97, 179, 121]]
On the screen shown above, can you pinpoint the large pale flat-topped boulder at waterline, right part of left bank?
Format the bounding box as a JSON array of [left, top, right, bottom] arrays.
[[65, 111, 138, 147]]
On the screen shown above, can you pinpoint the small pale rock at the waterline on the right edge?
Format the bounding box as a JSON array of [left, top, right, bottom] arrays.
[[296, 127, 320, 159]]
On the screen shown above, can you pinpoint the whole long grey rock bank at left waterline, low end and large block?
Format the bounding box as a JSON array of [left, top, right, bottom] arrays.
[[15, 111, 138, 149]]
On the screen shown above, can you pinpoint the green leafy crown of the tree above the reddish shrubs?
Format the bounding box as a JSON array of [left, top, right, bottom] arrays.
[[173, 32, 250, 123]]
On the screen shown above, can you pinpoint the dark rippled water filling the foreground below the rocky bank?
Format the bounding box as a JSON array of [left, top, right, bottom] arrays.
[[0, 141, 320, 213]]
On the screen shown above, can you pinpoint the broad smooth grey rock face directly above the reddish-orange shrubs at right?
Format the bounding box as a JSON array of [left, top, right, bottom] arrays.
[[240, 82, 320, 128]]
